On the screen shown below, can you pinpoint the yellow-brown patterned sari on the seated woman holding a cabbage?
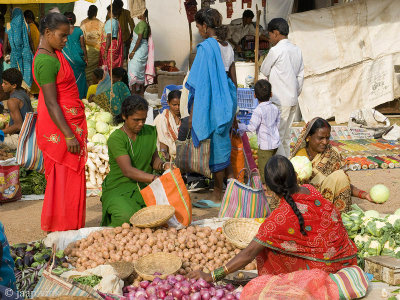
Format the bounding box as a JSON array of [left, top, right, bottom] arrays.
[[291, 119, 351, 212]]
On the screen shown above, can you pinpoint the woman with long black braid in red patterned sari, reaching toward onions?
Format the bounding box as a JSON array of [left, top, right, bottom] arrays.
[[189, 155, 357, 281]]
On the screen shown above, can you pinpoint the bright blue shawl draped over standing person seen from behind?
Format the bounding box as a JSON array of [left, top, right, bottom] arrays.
[[185, 38, 237, 171]]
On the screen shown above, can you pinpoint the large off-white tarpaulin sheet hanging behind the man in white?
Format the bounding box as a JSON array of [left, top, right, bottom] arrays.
[[289, 0, 400, 123]]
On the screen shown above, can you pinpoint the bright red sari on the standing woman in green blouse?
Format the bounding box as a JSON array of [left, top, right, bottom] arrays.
[[35, 51, 87, 231]]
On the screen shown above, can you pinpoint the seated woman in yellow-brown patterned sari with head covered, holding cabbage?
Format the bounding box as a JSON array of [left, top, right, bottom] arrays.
[[291, 118, 373, 212]]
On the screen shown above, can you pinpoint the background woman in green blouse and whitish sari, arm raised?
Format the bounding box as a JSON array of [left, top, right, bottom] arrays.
[[128, 9, 150, 95]]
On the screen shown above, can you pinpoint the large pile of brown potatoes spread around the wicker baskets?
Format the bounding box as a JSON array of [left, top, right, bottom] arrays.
[[65, 223, 256, 275]]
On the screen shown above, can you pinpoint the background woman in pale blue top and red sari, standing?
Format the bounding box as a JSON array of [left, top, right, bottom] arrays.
[[99, 5, 124, 70]]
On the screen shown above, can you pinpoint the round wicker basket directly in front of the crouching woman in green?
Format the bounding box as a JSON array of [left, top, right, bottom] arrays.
[[130, 205, 175, 228]]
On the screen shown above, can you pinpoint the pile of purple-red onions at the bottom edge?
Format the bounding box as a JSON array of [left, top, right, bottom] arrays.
[[123, 275, 240, 300]]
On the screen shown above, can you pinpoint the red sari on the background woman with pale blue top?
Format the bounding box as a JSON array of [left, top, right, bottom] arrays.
[[99, 20, 124, 70]]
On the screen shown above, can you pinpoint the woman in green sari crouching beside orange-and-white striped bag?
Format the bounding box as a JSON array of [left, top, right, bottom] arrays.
[[101, 95, 170, 227]]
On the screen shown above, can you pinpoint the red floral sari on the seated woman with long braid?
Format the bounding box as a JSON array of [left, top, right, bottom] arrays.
[[254, 184, 357, 275]]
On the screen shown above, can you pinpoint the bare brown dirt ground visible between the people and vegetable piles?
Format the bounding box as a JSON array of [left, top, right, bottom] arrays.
[[0, 169, 400, 244]]
